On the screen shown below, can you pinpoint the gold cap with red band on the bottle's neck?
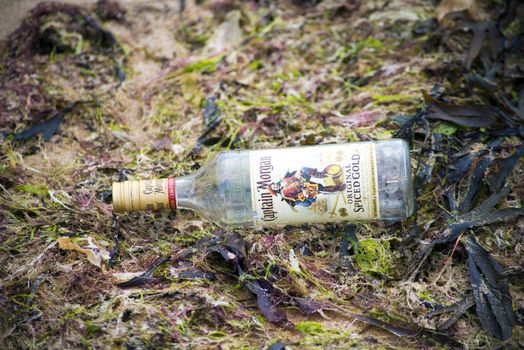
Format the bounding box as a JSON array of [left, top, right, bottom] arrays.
[[113, 178, 176, 213]]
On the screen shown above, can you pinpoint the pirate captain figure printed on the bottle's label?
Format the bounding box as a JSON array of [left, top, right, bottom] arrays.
[[268, 164, 346, 207]]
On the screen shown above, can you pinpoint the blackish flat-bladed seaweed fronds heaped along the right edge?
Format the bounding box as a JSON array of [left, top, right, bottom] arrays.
[[401, 22, 524, 340]]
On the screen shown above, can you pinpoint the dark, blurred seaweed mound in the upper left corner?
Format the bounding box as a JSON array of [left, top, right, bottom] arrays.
[[0, 2, 125, 141]]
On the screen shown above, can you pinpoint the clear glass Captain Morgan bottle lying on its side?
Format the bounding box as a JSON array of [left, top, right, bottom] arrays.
[[113, 139, 414, 228]]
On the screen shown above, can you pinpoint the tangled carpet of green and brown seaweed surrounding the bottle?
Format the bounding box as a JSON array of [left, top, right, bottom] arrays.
[[0, 0, 524, 349]]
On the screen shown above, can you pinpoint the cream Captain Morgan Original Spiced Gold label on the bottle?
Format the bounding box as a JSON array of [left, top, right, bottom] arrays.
[[250, 142, 380, 226]]
